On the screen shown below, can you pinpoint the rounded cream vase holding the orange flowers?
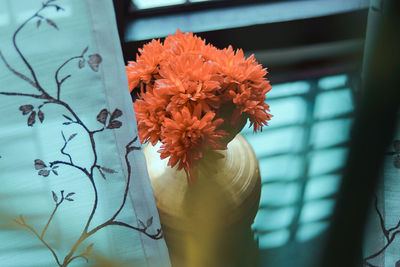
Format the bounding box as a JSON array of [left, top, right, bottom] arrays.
[[144, 134, 261, 267]]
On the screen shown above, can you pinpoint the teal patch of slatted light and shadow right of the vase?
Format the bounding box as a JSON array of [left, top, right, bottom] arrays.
[[242, 74, 354, 267]]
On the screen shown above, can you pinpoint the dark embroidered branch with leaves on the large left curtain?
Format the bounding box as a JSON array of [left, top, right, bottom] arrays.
[[0, 0, 162, 267]]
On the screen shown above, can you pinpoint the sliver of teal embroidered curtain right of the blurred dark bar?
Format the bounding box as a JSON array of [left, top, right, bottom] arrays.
[[363, 123, 400, 267]]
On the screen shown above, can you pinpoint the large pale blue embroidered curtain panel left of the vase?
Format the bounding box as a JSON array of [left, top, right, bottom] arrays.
[[0, 0, 169, 266]]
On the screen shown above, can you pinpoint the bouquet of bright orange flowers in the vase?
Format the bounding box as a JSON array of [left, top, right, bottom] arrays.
[[126, 30, 272, 182]]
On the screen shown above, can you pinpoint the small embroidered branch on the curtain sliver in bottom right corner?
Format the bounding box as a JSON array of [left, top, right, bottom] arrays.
[[363, 196, 400, 267]]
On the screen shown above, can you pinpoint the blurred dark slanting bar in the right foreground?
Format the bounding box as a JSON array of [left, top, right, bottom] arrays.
[[320, 0, 400, 267]]
